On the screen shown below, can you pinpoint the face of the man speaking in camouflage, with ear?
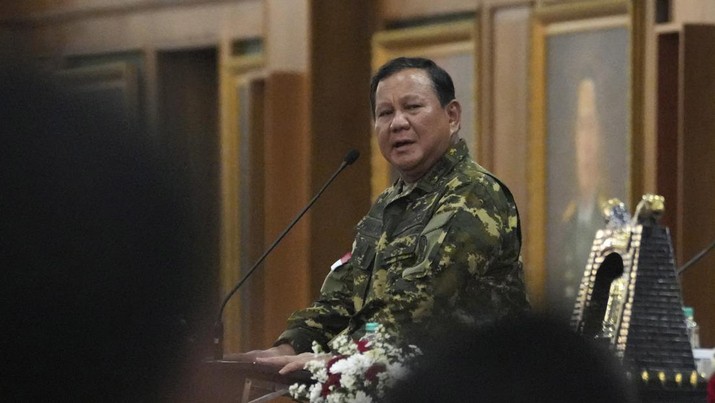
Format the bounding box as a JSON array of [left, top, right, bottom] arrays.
[[375, 69, 461, 182]]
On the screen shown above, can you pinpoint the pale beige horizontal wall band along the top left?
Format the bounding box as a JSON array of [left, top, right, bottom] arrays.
[[2, 0, 264, 55]]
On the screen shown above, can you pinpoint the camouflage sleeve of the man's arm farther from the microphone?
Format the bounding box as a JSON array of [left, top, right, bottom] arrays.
[[431, 183, 529, 323]]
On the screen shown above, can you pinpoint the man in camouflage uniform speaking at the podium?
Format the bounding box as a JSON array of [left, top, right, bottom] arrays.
[[249, 58, 528, 373]]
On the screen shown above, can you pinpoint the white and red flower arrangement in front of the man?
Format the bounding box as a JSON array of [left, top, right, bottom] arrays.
[[289, 326, 422, 403]]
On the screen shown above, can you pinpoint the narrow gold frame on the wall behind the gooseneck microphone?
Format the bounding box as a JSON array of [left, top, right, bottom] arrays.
[[219, 38, 266, 351]]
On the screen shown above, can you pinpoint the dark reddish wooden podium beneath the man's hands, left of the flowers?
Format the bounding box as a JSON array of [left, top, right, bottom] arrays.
[[192, 358, 312, 403]]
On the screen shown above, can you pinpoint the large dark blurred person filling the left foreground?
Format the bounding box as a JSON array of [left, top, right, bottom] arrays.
[[0, 46, 208, 402]]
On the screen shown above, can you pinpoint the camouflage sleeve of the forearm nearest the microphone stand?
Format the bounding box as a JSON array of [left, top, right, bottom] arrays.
[[274, 261, 354, 354]]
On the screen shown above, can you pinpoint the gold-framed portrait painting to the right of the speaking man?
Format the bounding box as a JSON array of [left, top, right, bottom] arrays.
[[525, 0, 641, 319]]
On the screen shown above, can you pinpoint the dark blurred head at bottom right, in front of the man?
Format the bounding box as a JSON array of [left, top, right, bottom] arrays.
[[389, 316, 634, 403]]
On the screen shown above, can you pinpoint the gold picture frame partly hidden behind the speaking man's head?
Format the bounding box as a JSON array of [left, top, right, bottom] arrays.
[[370, 19, 479, 199]]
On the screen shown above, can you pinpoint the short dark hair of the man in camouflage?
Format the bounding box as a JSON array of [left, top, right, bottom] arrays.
[[370, 57, 454, 118]]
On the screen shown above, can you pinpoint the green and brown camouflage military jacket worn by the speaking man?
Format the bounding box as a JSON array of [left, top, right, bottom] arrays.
[[276, 141, 528, 353]]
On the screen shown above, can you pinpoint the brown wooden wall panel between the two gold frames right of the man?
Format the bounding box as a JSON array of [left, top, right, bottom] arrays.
[[477, 0, 539, 295]]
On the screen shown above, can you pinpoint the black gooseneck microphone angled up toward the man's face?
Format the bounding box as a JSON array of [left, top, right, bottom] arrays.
[[213, 149, 360, 360]]
